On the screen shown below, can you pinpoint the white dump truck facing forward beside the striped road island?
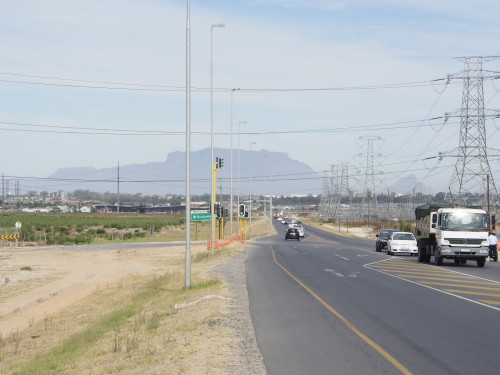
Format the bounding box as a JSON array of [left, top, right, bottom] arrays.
[[415, 201, 489, 267]]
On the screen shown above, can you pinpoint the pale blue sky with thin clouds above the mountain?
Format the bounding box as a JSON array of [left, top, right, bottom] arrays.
[[0, 0, 500, 197]]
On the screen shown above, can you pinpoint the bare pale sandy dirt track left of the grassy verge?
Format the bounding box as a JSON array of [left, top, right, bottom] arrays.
[[0, 246, 191, 337]]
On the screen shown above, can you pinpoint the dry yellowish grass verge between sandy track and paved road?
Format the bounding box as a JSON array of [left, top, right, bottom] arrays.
[[0, 220, 270, 375]]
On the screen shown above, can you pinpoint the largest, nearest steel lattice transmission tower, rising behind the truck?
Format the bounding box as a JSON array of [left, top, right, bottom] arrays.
[[444, 56, 500, 211]]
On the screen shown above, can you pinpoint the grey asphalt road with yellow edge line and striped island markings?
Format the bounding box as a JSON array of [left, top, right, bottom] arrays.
[[246, 222, 500, 375]]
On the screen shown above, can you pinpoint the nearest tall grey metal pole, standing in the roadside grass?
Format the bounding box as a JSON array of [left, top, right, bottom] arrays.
[[184, 0, 191, 288]]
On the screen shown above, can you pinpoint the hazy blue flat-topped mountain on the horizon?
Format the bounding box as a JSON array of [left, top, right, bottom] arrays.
[[48, 148, 321, 195]]
